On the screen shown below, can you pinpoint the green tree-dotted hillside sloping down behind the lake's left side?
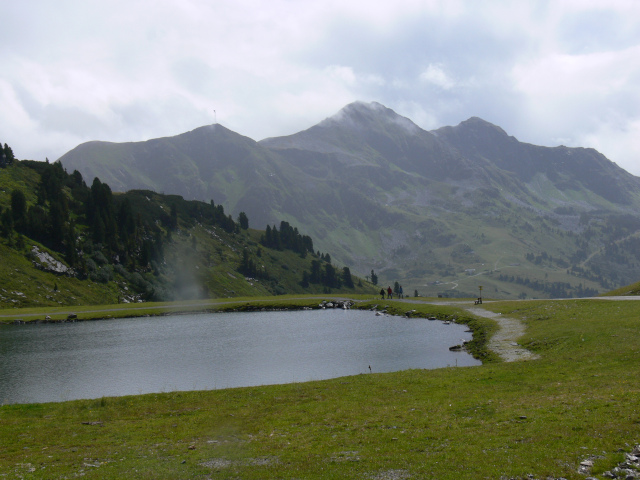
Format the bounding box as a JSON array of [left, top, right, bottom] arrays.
[[0, 156, 374, 308]]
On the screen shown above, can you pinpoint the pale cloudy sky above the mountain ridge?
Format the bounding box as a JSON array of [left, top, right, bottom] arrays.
[[0, 0, 640, 176]]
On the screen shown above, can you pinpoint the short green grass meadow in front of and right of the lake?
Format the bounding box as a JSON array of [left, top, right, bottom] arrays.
[[0, 300, 640, 479]]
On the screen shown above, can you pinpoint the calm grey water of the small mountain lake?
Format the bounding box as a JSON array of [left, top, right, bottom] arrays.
[[0, 310, 480, 404]]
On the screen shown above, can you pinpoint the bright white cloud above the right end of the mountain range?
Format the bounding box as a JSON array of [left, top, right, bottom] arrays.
[[512, 46, 640, 175]]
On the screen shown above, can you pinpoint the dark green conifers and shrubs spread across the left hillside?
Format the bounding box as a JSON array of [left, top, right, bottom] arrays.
[[0, 146, 368, 299]]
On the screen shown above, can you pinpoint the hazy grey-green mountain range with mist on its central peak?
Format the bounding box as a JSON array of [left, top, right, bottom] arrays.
[[59, 102, 640, 298]]
